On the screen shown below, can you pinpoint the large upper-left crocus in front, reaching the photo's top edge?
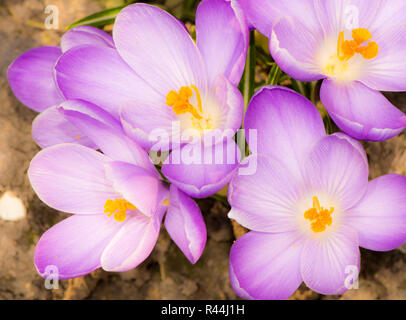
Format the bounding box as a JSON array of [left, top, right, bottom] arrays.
[[52, 0, 248, 198]]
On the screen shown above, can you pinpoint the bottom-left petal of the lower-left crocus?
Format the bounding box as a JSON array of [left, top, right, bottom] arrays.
[[34, 215, 122, 280]]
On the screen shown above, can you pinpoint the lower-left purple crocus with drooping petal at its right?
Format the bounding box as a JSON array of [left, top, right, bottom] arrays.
[[28, 100, 206, 279]]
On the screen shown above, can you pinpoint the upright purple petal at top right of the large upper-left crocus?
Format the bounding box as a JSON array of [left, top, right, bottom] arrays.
[[196, 0, 248, 85]]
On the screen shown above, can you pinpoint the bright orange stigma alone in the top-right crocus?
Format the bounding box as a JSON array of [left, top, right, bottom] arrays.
[[337, 28, 379, 61]]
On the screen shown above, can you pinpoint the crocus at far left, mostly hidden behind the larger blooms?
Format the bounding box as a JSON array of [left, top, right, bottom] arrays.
[[7, 26, 114, 148]]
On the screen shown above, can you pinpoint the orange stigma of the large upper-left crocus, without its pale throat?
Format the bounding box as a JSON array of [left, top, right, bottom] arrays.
[[166, 85, 203, 120]]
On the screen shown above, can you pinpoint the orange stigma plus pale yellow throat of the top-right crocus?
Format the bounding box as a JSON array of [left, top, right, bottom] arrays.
[[323, 28, 379, 80]]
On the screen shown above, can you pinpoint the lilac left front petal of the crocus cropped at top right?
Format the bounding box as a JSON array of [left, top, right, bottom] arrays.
[[269, 17, 324, 81]]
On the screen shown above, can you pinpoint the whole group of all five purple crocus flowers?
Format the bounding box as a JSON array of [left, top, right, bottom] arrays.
[[8, 0, 406, 299]]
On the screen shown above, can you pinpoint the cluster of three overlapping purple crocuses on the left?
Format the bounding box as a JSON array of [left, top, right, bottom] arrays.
[[8, 0, 248, 279]]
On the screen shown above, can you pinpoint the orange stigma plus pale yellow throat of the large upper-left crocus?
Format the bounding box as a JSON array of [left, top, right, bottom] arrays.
[[166, 85, 213, 130]]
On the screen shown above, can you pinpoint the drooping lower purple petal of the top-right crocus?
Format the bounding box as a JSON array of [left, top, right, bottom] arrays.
[[320, 80, 406, 141]]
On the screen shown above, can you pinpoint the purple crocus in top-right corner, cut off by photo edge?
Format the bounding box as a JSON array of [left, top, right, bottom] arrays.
[[240, 0, 406, 141]]
